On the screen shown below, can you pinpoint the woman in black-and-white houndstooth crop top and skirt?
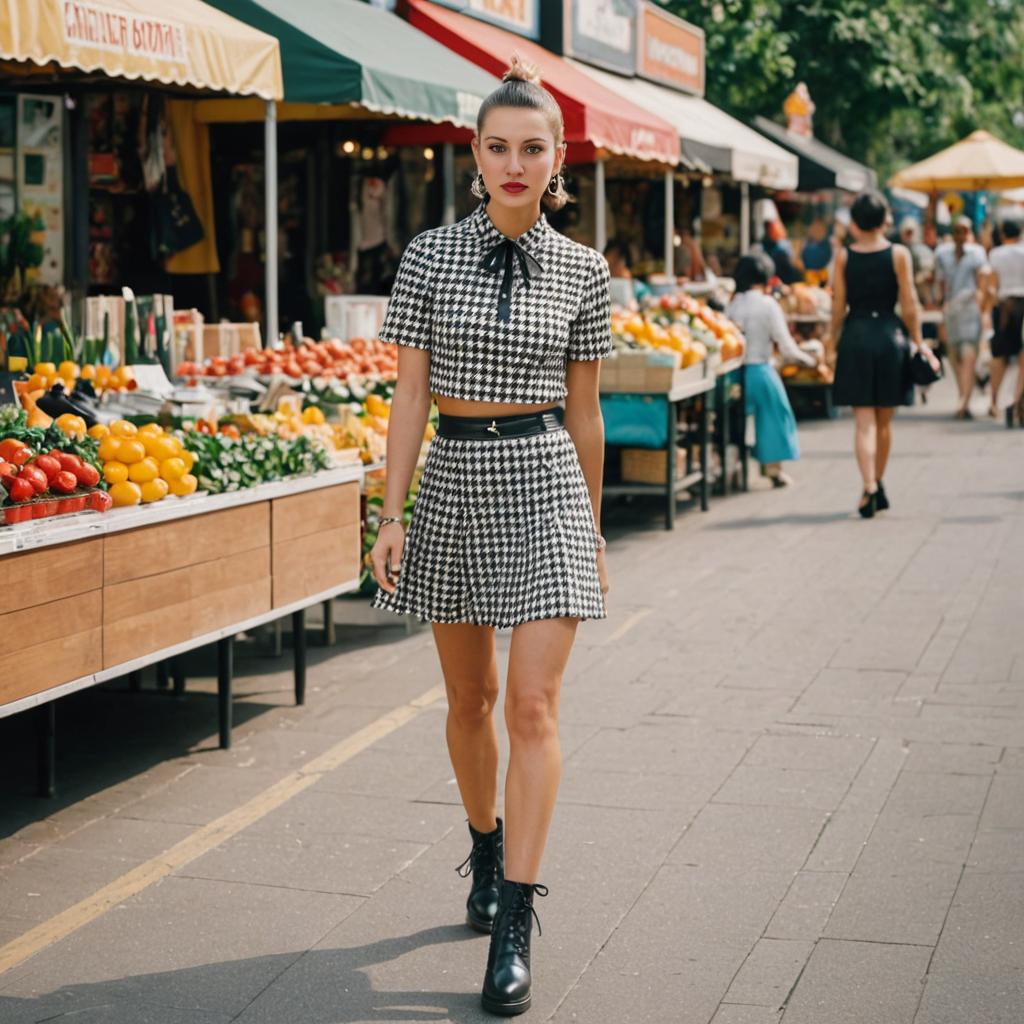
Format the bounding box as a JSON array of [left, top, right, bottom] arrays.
[[371, 58, 611, 1016]]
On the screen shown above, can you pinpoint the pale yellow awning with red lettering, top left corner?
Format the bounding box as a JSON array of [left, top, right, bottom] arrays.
[[0, 0, 284, 99]]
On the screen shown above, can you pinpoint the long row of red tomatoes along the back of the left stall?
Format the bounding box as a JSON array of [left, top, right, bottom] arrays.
[[176, 338, 398, 380]]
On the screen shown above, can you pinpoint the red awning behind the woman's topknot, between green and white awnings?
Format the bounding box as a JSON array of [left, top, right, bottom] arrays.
[[388, 0, 680, 166]]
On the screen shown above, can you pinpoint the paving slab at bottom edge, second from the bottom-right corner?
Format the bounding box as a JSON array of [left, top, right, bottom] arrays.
[[782, 940, 931, 1024]]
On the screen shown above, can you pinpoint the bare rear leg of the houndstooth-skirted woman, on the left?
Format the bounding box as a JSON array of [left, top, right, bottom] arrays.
[[434, 623, 498, 833]]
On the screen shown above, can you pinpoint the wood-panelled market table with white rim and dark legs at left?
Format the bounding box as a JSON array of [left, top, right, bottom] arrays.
[[0, 465, 362, 796]]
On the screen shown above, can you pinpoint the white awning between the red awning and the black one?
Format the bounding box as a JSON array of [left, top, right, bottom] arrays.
[[570, 60, 799, 189]]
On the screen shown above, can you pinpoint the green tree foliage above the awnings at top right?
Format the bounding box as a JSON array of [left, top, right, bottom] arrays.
[[659, 0, 1024, 176]]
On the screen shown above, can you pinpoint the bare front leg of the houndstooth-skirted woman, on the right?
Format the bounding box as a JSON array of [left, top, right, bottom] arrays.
[[505, 618, 578, 883]]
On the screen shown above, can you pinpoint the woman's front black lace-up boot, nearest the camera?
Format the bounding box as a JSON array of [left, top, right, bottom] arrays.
[[481, 882, 548, 1017]]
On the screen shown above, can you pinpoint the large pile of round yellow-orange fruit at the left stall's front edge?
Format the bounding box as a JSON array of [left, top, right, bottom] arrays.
[[91, 420, 199, 508]]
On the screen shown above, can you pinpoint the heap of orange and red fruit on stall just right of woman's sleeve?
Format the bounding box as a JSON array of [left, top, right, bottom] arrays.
[[611, 295, 744, 370]]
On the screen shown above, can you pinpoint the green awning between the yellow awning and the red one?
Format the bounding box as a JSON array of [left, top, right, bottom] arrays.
[[201, 0, 498, 127]]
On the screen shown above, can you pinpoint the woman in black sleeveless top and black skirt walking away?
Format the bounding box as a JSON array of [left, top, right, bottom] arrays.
[[831, 191, 939, 519]]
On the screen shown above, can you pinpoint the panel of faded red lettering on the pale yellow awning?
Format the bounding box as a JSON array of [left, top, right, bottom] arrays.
[[63, 0, 188, 65]]
